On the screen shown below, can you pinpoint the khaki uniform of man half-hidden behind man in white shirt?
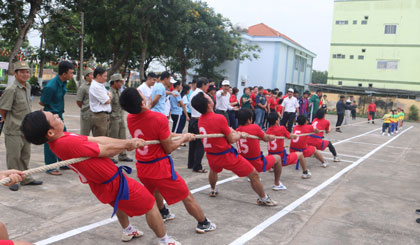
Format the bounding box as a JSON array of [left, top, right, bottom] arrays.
[[76, 83, 93, 136]]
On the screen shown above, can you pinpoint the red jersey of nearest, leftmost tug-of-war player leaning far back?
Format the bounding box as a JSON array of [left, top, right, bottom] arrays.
[[48, 132, 123, 203]]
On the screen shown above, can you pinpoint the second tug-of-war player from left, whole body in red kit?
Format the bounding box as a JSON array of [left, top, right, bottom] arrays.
[[120, 88, 216, 233]]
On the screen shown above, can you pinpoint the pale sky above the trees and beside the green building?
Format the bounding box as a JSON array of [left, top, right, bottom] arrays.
[[28, 0, 334, 71]]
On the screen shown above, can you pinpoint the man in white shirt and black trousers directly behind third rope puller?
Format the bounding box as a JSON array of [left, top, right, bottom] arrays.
[[188, 77, 209, 173]]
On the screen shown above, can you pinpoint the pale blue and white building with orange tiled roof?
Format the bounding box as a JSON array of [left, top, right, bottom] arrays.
[[218, 23, 316, 92]]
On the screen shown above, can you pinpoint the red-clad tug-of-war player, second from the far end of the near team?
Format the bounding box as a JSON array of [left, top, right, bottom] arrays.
[[290, 115, 328, 168]]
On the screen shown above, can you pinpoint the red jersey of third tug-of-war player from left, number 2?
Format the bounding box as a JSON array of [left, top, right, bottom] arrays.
[[198, 112, 231, 153]]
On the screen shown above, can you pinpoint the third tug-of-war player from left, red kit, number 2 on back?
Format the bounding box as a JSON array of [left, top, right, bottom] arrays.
[[191, 93, 277, 206]]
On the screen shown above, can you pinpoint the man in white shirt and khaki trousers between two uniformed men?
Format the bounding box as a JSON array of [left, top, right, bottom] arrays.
[[89, 67, 112, 137]]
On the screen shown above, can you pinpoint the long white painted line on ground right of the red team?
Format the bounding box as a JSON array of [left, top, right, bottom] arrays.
[[230, 126, 413, 245]]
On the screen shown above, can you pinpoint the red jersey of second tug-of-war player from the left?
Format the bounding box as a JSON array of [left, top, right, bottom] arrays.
[[127, 110, 172, 179]]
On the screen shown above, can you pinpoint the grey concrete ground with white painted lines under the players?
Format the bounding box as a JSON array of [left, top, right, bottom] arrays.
[[0, 95, 420, 244]]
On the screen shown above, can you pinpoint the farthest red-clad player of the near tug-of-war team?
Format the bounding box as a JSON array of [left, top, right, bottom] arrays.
[[308, 109, 340, 162]]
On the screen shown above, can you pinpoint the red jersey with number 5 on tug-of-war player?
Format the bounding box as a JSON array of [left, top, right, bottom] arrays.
[[236, 124, 265, 158]]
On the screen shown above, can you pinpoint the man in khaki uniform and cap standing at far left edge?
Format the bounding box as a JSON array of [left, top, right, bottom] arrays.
[[0, 61, 42, 191]]
